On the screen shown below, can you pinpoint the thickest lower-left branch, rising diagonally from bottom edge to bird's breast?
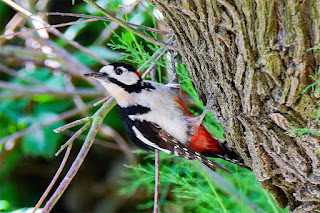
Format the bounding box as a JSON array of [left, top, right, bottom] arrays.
[[42, 98, 116, 212]]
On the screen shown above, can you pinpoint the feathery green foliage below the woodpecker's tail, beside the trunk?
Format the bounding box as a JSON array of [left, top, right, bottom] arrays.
[[119, 153, 288, 213]]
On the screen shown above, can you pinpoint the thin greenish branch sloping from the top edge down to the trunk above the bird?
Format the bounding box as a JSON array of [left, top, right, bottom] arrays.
[[83, 0, 178, 51]]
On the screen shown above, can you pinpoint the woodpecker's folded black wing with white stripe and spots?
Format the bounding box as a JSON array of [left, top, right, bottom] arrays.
[[132, 120, 230, 173]]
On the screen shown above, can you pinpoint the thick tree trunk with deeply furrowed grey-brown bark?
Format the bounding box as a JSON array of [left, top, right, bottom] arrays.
[[148, 0, 320, 212]]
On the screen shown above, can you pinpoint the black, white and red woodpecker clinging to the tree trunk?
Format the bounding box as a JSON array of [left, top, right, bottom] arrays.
[[85, 63, 242, 173]]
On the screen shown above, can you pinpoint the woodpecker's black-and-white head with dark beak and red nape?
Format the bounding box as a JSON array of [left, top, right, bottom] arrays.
[[84, 62, 141, 86]]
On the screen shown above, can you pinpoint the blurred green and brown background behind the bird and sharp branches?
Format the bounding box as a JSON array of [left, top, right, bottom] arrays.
[[0, 0, 288, 213]]
